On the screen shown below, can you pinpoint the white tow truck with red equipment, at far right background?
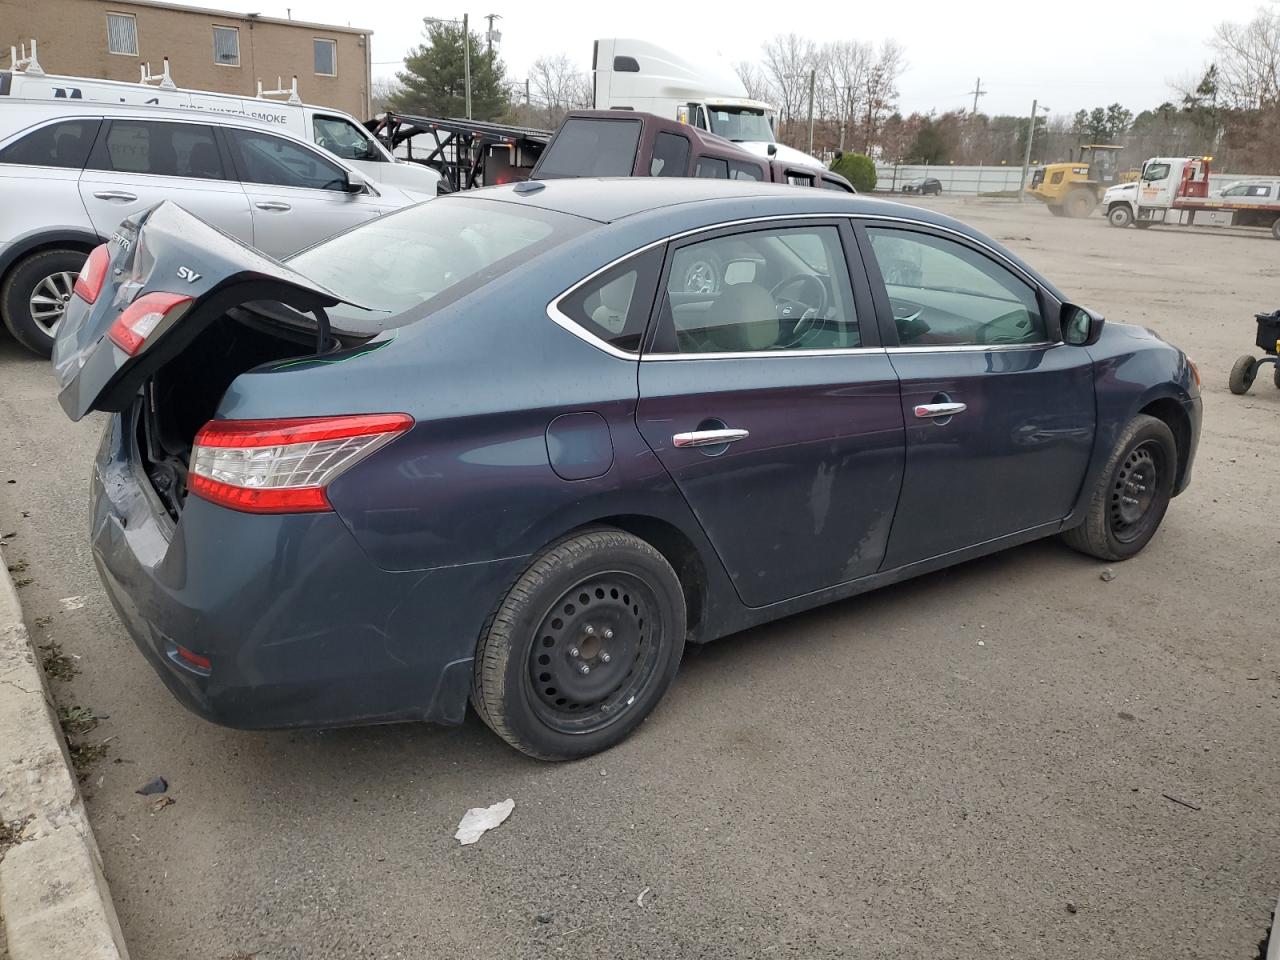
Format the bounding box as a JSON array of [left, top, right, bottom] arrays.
[[1102, 156, 1280, 239]]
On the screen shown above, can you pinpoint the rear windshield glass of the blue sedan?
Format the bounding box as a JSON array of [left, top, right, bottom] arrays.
[[288, 197, 590, 333]]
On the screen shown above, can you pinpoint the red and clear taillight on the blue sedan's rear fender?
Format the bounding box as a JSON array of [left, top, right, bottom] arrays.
[[187, 413, 413, 513]]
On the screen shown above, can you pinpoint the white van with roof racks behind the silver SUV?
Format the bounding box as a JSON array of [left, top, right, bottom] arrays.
[[0, 53, 440, 196]]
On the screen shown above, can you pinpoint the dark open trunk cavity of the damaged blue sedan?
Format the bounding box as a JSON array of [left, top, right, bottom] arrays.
[[135, 303, 367, 520]]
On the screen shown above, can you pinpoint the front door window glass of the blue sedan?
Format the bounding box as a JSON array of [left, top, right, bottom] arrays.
[[867, 227, 1048, 347]]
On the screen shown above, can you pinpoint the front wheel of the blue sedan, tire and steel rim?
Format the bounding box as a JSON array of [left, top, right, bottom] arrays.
[[1062, 413, 1178, 561]]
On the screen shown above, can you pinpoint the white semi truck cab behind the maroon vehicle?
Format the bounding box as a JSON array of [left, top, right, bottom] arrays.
[[591, 37, 824, 168]]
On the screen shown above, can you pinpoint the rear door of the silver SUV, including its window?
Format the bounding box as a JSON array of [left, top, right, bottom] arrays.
[[79, 119, 253, 243]]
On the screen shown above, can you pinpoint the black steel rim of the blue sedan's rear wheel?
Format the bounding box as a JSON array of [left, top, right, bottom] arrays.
[[526, 571, 664, 733]]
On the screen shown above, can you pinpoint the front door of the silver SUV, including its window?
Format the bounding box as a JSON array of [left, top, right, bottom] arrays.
[[224, 127, 396, 257]]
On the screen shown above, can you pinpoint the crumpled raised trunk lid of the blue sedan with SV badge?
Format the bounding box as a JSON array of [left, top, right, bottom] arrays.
[[54, 201, 367, 420]]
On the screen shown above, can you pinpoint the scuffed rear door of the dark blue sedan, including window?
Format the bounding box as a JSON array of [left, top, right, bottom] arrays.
[[637, 220, 902, 607]]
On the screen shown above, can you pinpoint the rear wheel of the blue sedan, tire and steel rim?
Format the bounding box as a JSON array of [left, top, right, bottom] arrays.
[[471, 529, 685, 760]]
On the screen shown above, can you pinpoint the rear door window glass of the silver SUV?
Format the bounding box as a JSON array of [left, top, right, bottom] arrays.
[[88, 120, 227, 180]]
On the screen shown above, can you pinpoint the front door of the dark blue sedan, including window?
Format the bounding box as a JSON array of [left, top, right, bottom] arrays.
[[859, 221, 1096, 570]]
